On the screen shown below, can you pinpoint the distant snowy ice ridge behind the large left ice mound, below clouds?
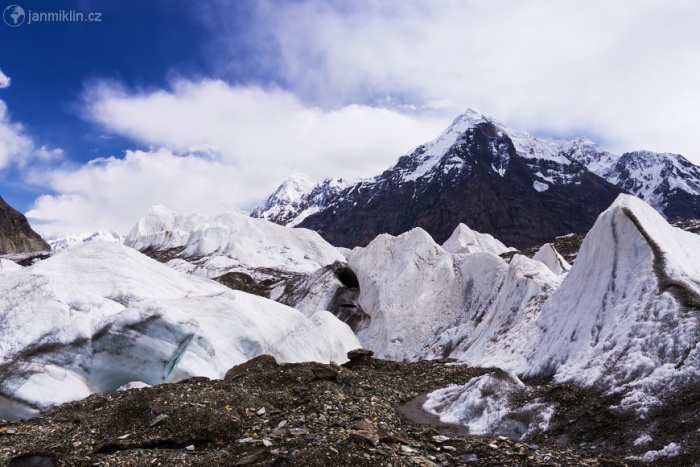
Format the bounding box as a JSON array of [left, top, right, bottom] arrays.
[[124, 206, 344, 277]]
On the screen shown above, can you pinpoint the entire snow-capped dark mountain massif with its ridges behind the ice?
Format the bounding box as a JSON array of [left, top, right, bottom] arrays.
[[251, 109, 700, 248]]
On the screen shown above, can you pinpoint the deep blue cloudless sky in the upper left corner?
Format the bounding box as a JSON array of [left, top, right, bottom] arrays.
[[0, 0, 215, 201]]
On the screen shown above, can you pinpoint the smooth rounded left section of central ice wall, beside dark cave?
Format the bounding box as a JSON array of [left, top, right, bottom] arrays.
[[348, 229, 464, 361]]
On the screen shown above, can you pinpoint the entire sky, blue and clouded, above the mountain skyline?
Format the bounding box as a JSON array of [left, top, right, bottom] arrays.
[[0, 0, 700, 233]]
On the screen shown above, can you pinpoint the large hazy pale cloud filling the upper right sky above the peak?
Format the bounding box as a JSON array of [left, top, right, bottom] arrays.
[[208, 0, 700, 162]]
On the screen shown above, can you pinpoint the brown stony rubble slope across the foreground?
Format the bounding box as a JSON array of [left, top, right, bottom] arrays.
[[0, 353, 652, 467]]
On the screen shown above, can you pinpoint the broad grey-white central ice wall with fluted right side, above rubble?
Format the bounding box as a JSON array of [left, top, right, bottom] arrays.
[[348, 223, 561, 365]]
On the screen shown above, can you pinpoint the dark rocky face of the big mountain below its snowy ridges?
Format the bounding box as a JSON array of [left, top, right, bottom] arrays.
[[290, 122, 623, 248]]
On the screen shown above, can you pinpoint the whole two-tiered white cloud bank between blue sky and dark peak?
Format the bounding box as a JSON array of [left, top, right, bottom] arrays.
[[27, 81, 448, 234]]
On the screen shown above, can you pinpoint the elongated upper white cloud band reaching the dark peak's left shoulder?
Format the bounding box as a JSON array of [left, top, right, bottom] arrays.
[[86, 81, 449, 180]]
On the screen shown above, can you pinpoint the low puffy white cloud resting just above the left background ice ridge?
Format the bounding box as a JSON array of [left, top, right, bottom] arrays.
[[27, 149, 250, 235]]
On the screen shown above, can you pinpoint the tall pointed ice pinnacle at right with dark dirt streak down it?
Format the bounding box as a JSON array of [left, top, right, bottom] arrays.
[[465, 195, 700, 412]]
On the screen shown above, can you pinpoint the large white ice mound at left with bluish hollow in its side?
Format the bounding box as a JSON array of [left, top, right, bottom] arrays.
[[0, 241, 360, 419]]
